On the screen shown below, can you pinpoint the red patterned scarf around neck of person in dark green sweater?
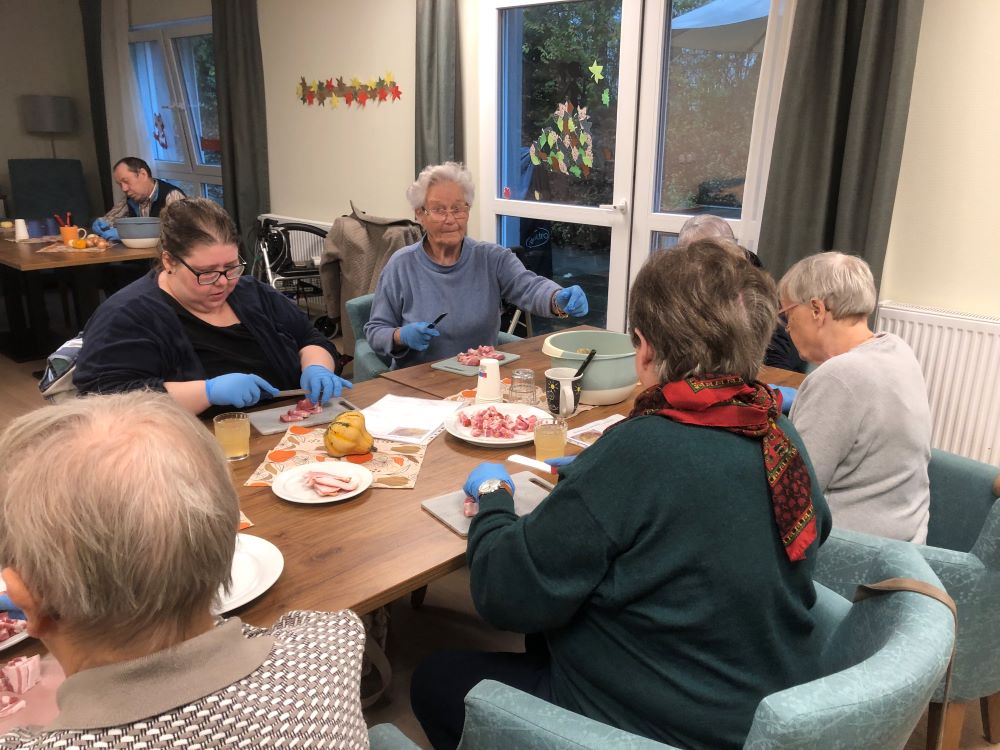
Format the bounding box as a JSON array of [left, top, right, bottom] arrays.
[[629, 375, 816, 560]]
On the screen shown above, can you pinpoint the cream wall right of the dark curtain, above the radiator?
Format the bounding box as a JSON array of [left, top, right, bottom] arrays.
[[881, 0, 1000, 315]]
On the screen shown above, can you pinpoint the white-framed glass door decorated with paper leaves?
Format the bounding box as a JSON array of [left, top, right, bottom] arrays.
[[479, 0, 641, 334]]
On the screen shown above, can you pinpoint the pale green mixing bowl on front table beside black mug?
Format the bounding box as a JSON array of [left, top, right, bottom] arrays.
[[542, 331, 638, 406]]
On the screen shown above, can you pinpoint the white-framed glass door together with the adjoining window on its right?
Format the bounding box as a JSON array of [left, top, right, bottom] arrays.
[[480, 0, 794, 333]]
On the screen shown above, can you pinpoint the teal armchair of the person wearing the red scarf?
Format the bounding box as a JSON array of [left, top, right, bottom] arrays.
[[459, 545, 955, 750]]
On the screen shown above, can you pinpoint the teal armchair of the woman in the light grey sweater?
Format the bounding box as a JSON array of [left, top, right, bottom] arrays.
[[816, 449, 1000, 750]]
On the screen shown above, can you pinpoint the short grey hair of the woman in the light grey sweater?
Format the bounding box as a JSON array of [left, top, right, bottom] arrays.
[[778, 250, 877, 320]]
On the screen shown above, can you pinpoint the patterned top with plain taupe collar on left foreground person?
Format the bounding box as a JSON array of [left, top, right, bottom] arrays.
[[0, 610, 368, 750]]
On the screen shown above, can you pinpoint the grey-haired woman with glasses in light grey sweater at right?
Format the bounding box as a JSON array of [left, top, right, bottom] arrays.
[[778, 252, 931, 543]]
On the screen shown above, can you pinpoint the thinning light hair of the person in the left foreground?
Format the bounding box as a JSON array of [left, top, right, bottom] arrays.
[[0, 391, 239, 643]]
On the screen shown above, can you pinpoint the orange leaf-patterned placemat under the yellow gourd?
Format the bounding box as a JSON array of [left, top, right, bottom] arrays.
[[245, 425, 426, 489]]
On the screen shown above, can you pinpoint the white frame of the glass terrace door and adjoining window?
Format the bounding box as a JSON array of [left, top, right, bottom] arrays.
[[478, 0, 797, 331]]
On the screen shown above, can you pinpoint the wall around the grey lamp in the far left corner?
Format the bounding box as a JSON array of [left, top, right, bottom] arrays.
[[0, 0, 104, 218]]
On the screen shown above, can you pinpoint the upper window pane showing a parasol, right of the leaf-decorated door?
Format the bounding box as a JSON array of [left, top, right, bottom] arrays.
[[656, 0, 768, 218]]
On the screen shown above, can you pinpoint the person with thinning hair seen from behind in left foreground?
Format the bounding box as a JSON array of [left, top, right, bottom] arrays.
[[0, 391, 368, 750]]
